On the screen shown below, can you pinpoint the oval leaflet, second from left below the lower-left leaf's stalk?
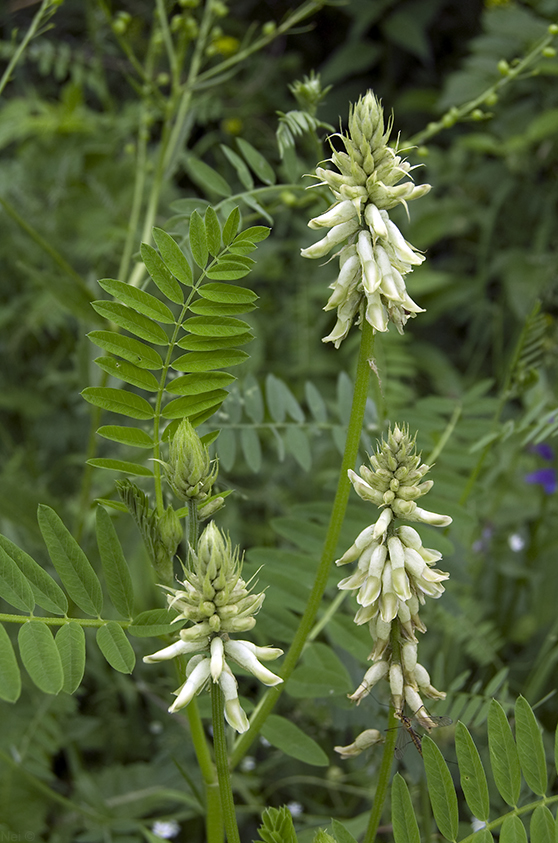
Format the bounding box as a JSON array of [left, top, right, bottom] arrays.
[[17, 621, 64, 694]]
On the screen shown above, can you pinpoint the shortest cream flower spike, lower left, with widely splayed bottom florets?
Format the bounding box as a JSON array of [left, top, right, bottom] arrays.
[[144, 521, 283, 732]]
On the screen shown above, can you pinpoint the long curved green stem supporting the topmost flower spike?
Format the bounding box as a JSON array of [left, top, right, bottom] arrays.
[[231, 321, 374, 768]]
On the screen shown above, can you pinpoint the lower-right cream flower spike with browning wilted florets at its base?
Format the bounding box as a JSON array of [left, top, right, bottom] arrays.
[[336, 425, 451, 757]]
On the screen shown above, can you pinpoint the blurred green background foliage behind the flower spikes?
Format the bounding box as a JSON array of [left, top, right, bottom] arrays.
[[0, 0, 558, 843]]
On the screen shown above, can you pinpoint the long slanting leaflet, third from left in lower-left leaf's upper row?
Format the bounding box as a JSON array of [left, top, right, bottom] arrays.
[[38, 504, 103, 617]]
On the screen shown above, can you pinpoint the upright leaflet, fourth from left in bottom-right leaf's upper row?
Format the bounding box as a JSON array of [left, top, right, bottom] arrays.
[[488, 700, 521, 807]]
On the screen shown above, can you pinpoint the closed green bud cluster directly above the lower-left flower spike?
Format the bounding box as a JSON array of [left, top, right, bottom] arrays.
[[163, 419, 219, 502]]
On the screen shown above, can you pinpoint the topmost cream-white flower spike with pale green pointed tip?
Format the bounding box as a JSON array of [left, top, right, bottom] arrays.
[[302, 91, 430, 348]]
